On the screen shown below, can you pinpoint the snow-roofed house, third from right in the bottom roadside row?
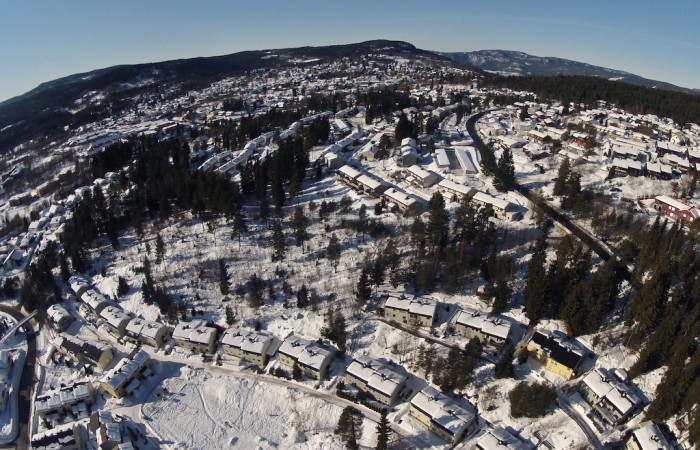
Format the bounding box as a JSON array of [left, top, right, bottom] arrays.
[[345, 355, 407, 406]]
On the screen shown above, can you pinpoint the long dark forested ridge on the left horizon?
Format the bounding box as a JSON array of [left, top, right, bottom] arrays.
[[0, 40, 450, 153]]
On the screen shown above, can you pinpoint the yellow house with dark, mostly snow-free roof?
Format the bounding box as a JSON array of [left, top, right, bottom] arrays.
[[527, 330, 586, 380]]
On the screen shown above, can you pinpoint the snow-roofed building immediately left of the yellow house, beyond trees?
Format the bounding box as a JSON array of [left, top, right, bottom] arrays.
[[450, 307, 511, 346]]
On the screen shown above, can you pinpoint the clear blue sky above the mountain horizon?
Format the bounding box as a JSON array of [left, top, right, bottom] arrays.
[[0, 0, 700, 101]]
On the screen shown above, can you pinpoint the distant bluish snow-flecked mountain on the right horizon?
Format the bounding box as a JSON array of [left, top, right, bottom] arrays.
[[438, 50, 700, 94]]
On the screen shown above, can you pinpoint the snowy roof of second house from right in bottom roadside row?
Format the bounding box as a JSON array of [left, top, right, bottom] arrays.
[[411, 386, 475, 436]]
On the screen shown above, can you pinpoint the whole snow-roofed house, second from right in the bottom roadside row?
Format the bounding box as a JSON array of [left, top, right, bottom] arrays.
[[408, 386, 476, 444]]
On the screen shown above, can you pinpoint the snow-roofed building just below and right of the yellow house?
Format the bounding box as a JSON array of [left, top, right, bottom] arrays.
[[580, 368, 643, 426]]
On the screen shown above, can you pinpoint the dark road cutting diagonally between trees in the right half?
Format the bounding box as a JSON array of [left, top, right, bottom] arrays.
[[467, 111, 640, 289]]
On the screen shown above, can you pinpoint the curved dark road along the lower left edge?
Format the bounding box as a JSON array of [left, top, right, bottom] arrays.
[[0, 304, 37, 449]]
